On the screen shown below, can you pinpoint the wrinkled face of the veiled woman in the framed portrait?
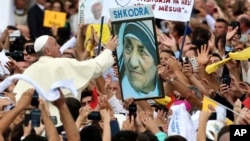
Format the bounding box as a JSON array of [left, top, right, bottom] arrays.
[[123, 37, 156, 93]]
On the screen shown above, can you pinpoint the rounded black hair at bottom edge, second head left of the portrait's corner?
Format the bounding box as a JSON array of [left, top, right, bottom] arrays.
[[80, 125, 102, 141]]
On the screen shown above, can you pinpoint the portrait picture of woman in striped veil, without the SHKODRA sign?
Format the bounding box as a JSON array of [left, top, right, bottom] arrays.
[[117, 20, 162, 99]]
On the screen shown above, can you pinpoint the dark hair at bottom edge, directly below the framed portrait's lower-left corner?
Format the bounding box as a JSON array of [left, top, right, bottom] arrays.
[[112, 130, 138, 141]]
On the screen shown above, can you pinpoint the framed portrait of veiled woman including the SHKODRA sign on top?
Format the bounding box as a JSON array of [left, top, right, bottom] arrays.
[[110, 5, 164, 100]]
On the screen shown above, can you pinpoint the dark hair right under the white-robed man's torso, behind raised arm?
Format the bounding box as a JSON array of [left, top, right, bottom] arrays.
[[65, 97, 81, 121]]
